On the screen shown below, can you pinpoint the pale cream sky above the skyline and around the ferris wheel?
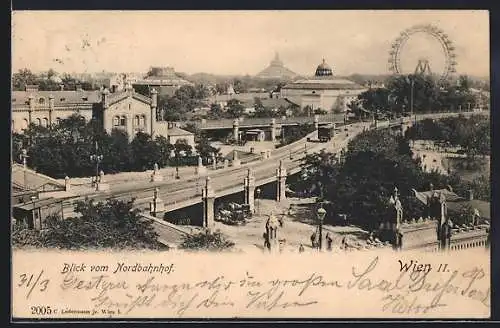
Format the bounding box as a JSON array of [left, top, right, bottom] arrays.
[[12, 10, 490, 76]]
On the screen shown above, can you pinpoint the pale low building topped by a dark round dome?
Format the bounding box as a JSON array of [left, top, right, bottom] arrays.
[[281, 59, 367, 112]]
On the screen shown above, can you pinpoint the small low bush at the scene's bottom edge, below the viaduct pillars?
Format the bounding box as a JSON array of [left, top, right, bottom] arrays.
[[180, 230, 234, 252]]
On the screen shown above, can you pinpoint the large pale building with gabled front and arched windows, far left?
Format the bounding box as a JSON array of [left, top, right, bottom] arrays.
[[12, 84, 194, 143]]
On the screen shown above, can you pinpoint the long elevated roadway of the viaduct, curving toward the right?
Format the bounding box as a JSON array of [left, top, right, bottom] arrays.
[[59, 113, 488, 218]]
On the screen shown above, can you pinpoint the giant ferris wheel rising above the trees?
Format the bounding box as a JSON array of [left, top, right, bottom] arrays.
[[388, 25, 457, 81]]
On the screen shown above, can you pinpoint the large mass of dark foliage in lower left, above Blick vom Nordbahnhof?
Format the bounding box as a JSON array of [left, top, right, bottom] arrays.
[[13, 199, 167, 250]]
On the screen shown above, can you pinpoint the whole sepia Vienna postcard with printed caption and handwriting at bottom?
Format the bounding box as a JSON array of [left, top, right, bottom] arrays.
[[11, 10, 491, 319]]
